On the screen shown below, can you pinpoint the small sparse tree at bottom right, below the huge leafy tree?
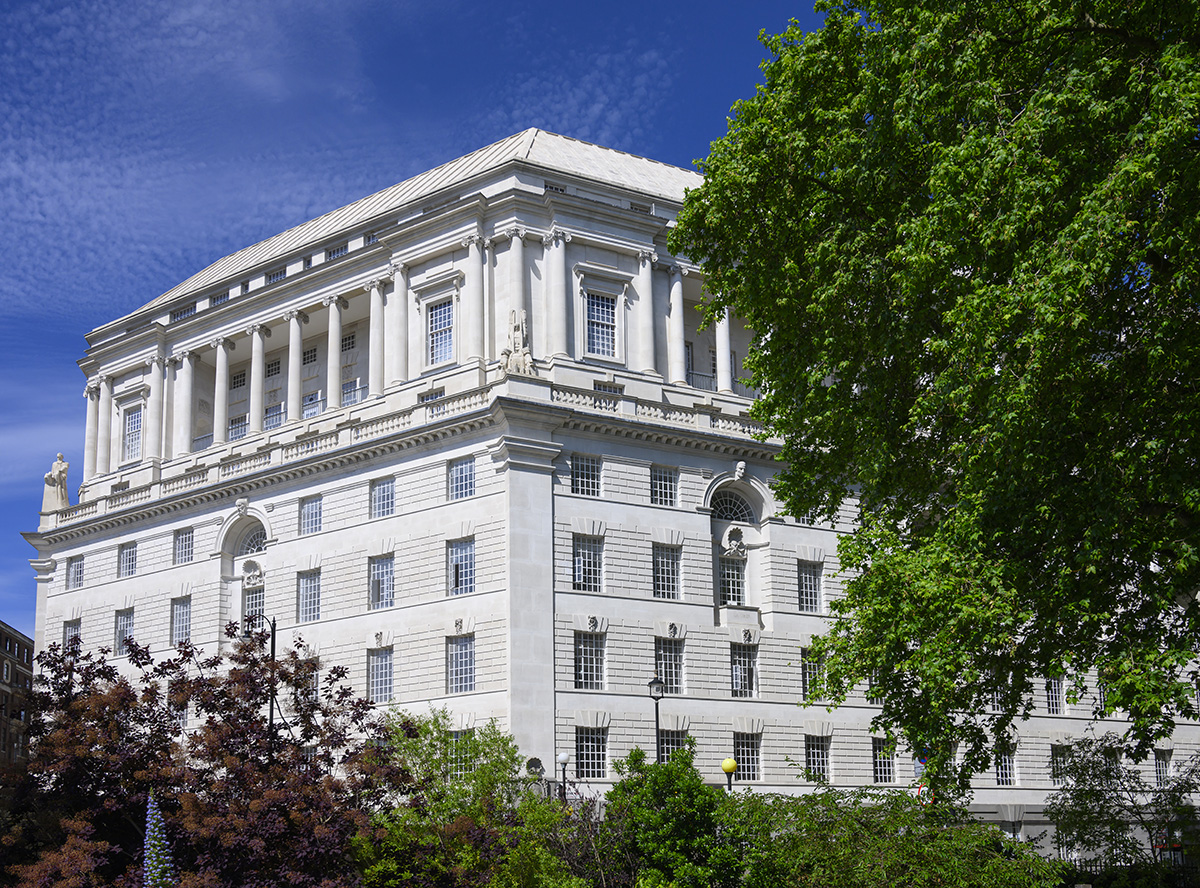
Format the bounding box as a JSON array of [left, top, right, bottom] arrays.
[[1045, 733, 1200, 863]]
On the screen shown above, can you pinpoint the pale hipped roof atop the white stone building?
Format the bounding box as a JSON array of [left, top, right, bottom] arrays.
[[134, 130, 702, 313]]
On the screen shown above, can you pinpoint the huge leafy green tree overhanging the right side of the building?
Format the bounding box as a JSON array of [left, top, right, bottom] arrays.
[[671, 0, 1200, 779]]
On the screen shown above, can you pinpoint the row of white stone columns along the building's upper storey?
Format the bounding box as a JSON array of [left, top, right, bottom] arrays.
[[84, 226, 733, 484]]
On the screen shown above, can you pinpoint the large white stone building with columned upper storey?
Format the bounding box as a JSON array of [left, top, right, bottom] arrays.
[[28, 130, 1195, 829]]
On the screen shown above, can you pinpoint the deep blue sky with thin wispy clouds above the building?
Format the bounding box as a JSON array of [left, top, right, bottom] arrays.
[[0, 0, 820, 635]]
